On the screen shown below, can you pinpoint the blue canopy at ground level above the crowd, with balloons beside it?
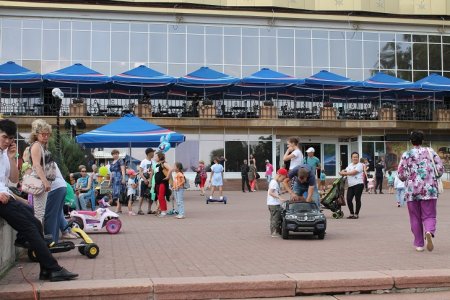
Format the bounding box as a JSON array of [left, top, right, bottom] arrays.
[[76, 114, 185, 148]]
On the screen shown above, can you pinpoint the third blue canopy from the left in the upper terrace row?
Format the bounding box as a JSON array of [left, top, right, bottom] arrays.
[[111, 65, 177, 94]]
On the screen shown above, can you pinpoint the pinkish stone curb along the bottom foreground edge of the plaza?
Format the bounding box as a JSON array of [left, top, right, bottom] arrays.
[[0, 269, 450, 300]]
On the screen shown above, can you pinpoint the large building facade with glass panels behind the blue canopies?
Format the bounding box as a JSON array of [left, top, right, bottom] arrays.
[[0, 0, 450, 177]]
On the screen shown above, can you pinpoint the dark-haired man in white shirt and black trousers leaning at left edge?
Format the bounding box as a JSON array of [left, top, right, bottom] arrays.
[[0, 119, 78, 281]]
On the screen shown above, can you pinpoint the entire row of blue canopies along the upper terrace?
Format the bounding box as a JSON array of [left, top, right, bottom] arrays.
[[0, 61, 450, 95]]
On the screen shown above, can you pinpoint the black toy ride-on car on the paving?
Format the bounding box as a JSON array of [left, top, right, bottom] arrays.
[[281, 202, 327, 240]]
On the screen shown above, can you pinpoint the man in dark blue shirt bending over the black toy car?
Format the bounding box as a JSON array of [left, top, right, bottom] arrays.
[[283, 164, 320, 208]]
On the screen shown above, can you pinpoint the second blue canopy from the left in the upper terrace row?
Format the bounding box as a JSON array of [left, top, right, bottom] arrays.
[[42, 64, 111, 97]]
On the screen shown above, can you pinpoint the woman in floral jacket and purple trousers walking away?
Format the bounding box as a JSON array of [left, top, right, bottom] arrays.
[[398, 131, 444, 252]]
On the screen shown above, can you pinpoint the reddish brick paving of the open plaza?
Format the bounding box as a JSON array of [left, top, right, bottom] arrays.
[[0, 190, 450, 285]]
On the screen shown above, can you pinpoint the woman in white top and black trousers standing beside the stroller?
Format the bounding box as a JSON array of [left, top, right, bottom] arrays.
[[339, 152, 364, 219]]
